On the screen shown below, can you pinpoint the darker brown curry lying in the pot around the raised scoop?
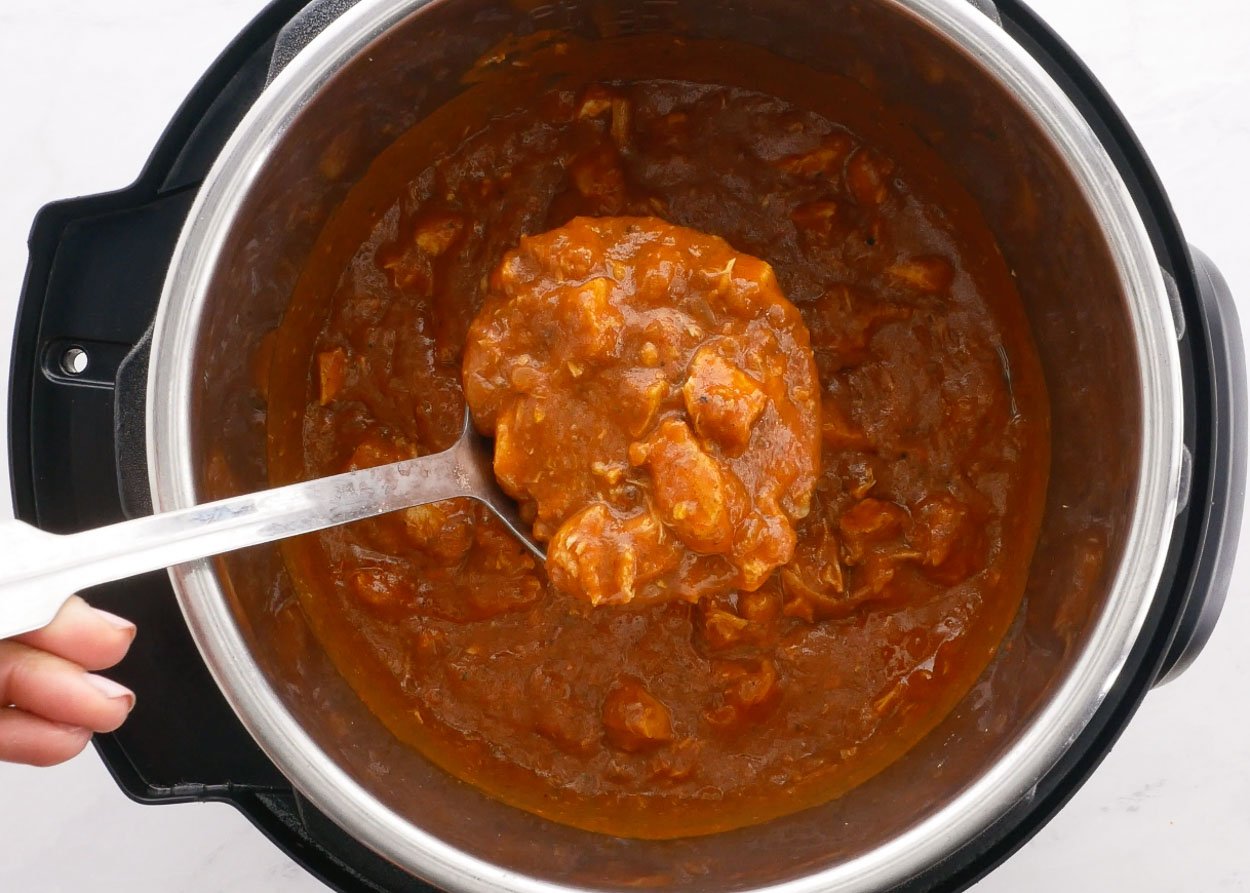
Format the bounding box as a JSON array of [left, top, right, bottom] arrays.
[[269, 62, 1049, 838]]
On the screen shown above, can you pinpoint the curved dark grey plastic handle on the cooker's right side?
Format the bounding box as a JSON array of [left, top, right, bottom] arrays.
[[1155, 245, 1246, 687]]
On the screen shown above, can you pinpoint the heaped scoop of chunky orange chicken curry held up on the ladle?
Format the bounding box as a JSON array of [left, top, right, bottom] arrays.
[[464, 218, 820, 604]]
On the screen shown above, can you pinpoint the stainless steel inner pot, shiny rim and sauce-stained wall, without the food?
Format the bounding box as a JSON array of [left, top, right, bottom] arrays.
[[148, 0, 1183, 892]]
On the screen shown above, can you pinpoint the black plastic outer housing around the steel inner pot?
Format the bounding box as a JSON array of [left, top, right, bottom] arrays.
[[9, 0, 1245, 890]]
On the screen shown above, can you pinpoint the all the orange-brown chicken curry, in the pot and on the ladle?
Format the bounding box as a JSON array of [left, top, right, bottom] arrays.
[[269, 45, 1049, 838]]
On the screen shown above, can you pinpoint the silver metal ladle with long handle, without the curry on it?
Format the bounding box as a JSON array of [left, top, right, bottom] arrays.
[[0, 413, 546, 639]]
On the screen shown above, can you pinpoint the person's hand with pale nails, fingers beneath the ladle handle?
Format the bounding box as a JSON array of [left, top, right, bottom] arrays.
[[0, 595, 135, 765]]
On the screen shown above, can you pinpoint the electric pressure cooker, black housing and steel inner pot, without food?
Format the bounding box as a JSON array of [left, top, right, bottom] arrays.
[[9, 0, 1245, 893]]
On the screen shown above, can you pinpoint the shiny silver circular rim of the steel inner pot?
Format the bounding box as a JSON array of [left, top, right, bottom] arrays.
[[148, 0, 1183, 893]]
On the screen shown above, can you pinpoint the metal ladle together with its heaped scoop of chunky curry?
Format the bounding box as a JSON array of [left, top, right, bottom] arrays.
[[0, 218, 820, 638]]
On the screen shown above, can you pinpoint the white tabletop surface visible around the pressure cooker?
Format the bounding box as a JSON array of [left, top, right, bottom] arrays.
[[0, 0, 1250, 893]]
